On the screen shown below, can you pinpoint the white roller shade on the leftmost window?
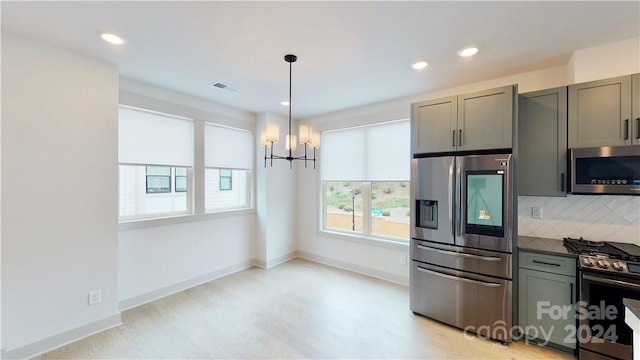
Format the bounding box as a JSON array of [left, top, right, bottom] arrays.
[[118, 106, 194, 166]]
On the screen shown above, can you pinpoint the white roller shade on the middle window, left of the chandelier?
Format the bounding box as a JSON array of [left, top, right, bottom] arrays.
[[204, 124, 253, 169]]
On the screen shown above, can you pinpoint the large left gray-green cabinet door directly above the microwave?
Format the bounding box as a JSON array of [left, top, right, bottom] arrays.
[[569, 75, 640, 148]]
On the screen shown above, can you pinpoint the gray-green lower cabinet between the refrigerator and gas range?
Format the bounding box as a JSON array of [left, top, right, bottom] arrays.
[[518, 251, 576, 349]]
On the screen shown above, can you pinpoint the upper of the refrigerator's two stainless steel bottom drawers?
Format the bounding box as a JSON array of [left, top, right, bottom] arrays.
[[411, 239, 513, 279]]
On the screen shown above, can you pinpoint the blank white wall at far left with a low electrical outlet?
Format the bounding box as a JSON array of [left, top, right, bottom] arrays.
[[2, 33, 120, 357]]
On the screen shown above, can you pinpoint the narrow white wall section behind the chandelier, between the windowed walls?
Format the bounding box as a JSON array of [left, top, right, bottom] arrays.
[[256, 113, 304, 268]]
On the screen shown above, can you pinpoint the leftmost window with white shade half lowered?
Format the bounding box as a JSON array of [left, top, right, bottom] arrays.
[[118, 106, 194, 221]]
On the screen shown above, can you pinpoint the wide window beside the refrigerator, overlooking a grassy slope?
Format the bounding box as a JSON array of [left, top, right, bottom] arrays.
[[320, 120, 410, 240]]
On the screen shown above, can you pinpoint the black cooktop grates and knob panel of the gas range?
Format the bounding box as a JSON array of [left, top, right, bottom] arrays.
[[563, 238, 640, 277]]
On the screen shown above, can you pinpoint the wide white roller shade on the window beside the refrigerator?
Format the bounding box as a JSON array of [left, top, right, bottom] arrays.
[[320, 120, 411, 181]]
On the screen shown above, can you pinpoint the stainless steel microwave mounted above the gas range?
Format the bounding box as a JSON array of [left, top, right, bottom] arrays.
[[570, 145, 640, 195]]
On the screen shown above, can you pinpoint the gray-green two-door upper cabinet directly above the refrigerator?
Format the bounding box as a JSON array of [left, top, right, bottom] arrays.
[[411, 86, 515, 154]]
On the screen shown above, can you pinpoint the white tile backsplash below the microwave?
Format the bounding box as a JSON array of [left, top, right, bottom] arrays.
[[518, 195, 640, 245]]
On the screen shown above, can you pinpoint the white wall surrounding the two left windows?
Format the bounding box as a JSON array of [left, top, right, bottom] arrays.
[[118, 79, 256, 309]]
